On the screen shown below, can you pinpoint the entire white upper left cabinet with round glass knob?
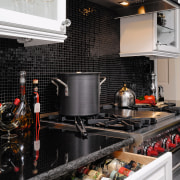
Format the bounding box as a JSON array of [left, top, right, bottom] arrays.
[[0, 0, 70, 46]]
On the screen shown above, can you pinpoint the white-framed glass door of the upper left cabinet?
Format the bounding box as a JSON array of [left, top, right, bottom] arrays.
[[0, 0, 66, 34]]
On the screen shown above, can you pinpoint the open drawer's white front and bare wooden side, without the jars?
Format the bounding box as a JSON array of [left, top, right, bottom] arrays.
[[113, 151, 172, 180]]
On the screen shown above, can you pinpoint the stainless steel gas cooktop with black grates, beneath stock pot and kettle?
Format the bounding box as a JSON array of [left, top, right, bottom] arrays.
[[40, 103, 180, 140]]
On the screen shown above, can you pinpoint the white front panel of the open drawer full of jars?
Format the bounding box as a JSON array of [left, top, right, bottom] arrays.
[[126, 152, 172, 180]]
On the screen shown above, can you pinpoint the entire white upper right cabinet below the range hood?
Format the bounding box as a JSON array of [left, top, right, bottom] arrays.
[[120, 9, 180, 57]]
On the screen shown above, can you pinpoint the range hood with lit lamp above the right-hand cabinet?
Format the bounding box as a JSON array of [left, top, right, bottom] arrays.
[[89, 0, 180, 17]]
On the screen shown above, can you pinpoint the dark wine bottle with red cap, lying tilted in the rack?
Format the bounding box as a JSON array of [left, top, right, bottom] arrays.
[[2, 98, 20, 124]]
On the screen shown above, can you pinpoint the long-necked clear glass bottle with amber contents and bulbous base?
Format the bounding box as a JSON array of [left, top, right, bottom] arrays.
[[15, 71, 33, 130]]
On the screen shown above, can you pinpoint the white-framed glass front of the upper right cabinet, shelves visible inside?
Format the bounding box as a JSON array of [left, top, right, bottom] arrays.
[[154, 9, 179, 53]]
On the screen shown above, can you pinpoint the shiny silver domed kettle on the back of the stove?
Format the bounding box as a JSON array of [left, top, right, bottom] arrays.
[[115, 84, 136, 108]]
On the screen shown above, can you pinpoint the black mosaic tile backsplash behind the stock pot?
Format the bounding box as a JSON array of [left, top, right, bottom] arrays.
[[0, 0, 153, 112]]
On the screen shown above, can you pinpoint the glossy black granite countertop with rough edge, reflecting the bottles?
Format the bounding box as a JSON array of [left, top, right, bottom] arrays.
[[0, 123, 134, 180]]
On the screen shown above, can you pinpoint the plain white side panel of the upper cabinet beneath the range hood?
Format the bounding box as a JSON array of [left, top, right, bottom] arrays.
[[120, 13, 154, 55]]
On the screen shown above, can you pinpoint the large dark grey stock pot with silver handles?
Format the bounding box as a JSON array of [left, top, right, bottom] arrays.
[[52, 72, 106, 116]]
